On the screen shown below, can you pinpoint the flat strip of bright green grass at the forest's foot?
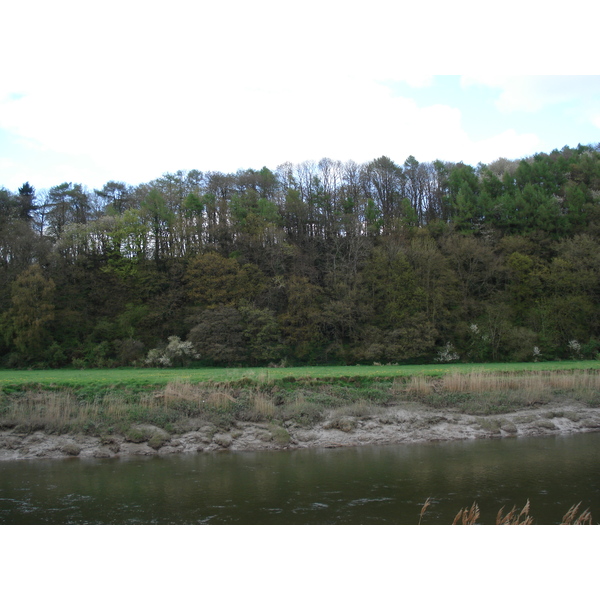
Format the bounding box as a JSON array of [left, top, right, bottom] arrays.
[[0, 360, 600, 388]]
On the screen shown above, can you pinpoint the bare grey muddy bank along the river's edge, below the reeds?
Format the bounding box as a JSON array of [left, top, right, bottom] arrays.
[[0, 403, 600, 460]]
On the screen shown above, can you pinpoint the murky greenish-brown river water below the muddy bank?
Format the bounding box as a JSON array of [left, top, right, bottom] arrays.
[[0, 433, 600, 525]]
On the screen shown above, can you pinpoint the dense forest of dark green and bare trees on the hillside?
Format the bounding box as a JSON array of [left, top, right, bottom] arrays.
[[0, 144, 600, 368]]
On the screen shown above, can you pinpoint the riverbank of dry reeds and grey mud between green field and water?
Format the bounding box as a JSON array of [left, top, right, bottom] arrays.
[[0, 370, 600, 460]]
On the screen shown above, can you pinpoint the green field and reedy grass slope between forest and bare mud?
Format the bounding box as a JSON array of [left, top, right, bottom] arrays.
[[0, 361, 600, 436]]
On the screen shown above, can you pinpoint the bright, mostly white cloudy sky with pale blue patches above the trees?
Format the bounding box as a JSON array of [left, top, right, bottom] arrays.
[[0, 0, 600, 191]]
